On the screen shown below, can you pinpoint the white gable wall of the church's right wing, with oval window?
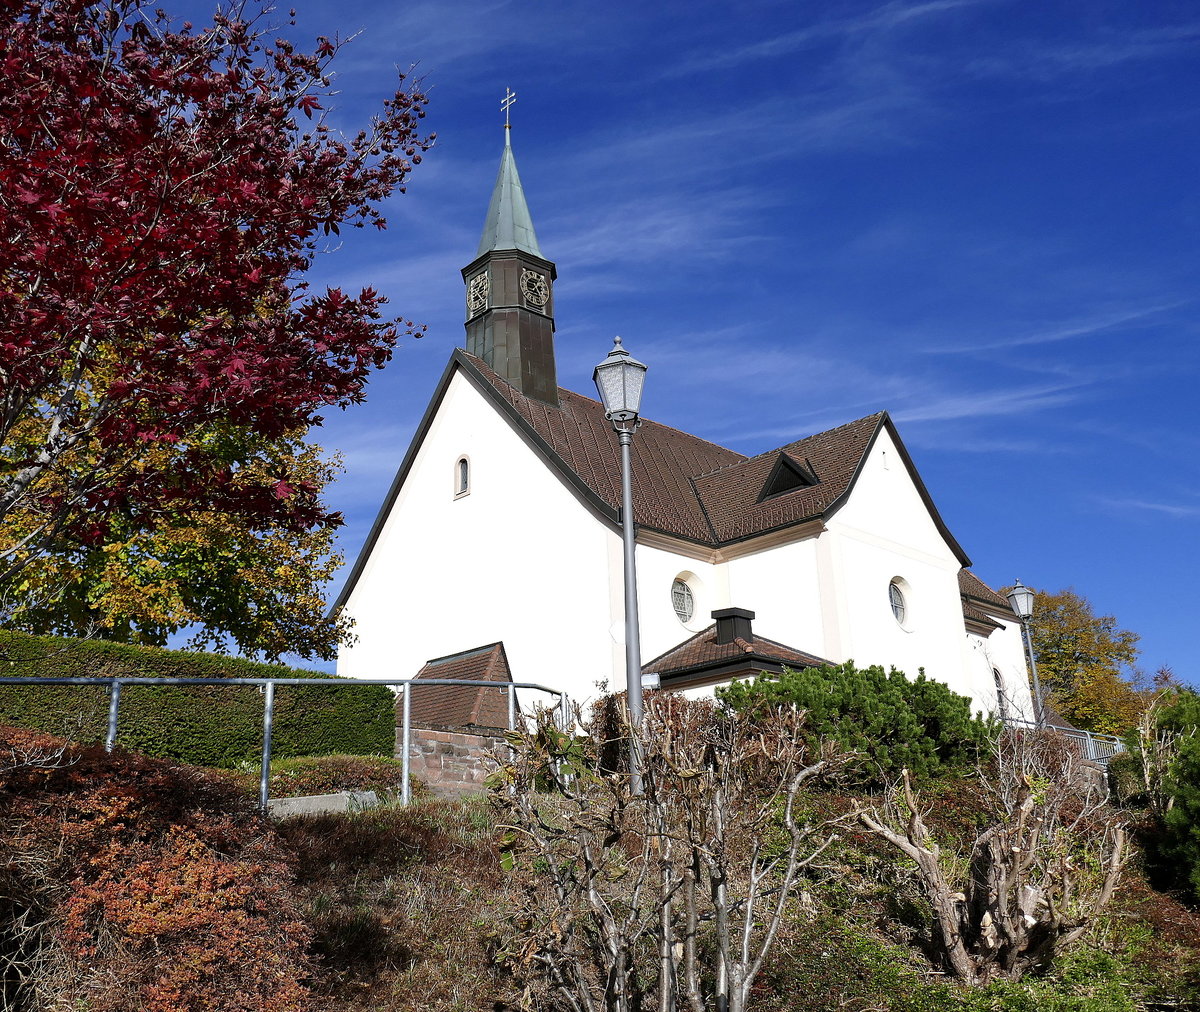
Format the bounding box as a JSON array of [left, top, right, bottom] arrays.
[[822, 431, 995, 708]]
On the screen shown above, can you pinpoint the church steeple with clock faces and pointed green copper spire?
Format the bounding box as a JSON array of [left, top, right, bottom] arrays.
[[462, 115, 558, 406]]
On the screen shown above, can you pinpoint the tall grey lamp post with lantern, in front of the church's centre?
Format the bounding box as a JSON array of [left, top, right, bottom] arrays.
[[592, 337, 646, 794]]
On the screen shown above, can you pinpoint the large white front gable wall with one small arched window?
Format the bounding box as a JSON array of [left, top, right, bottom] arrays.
[[337, 373, 623, 697]]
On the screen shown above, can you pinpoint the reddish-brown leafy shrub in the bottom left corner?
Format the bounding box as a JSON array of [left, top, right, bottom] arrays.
[[0, 729, 310, 1012]]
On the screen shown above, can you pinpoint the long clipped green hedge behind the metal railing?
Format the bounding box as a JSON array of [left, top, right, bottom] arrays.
[[0, 631, 396, 767]]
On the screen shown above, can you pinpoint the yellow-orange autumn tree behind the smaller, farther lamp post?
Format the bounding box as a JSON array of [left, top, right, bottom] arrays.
[[1030, 587, 1146, 735]]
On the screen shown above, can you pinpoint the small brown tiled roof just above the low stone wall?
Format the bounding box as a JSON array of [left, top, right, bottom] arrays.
[[397, 643, 514, 727]]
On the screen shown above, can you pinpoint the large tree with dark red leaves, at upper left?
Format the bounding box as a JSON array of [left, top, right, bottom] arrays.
[[0, 0, 432, 601]]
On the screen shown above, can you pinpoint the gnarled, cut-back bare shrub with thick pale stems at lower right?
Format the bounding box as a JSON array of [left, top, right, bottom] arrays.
[[858, 733, 1127, 984]]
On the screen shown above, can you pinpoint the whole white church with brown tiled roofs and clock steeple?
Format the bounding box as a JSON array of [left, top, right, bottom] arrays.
[[336, 131, 1032, 718]]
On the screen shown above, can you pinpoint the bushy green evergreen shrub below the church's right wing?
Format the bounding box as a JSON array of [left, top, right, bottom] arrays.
[[718, 660, 998, 783]]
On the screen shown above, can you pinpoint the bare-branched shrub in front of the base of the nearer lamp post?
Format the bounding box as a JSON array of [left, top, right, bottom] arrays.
[[493, 694, 841, 1012]]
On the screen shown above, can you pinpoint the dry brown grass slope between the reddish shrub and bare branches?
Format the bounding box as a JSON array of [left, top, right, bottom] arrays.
[[280, 798, 518, 1012]]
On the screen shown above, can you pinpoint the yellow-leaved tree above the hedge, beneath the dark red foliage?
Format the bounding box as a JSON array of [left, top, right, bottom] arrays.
[[2, 425, 347, 660]]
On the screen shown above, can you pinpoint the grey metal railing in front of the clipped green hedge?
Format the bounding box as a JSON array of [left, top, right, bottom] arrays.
[[0, 676, 570, 812]]
